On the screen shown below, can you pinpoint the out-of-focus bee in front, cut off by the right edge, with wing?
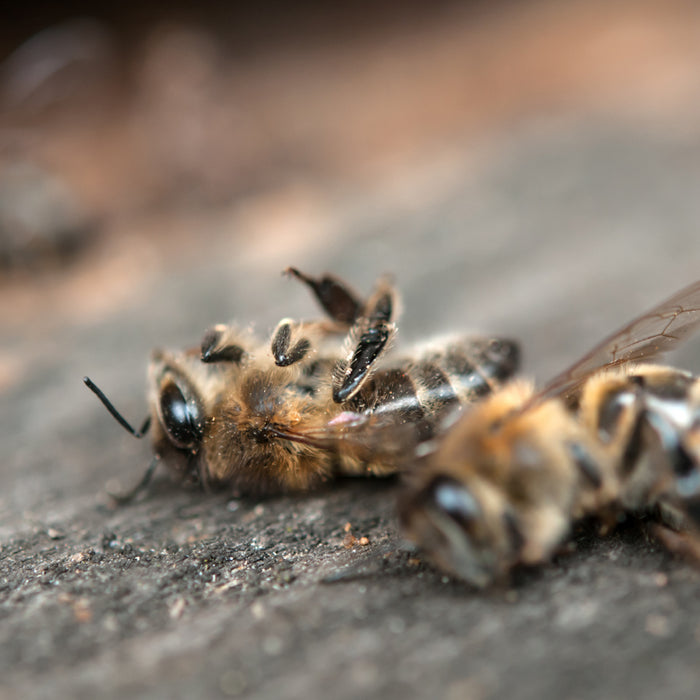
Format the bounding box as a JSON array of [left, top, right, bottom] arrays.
[[399, 282, 700, 588]]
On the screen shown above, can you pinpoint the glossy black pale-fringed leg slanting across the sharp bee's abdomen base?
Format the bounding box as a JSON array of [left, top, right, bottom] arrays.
[[333, 282, 396, 403]]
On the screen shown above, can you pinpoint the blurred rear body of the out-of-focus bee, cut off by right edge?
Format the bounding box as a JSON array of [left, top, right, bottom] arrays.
[[580, 365, 700, 527]]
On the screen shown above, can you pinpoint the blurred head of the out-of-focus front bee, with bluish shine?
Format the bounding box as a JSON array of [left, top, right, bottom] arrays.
[[399, 475, 510, 588]]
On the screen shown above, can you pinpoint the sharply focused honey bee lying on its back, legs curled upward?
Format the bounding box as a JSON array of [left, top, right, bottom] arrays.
[[84, 268, 519, 501]]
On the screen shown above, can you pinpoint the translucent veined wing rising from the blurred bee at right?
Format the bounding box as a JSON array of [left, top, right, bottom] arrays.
[[532, 280, 700, 402]]
